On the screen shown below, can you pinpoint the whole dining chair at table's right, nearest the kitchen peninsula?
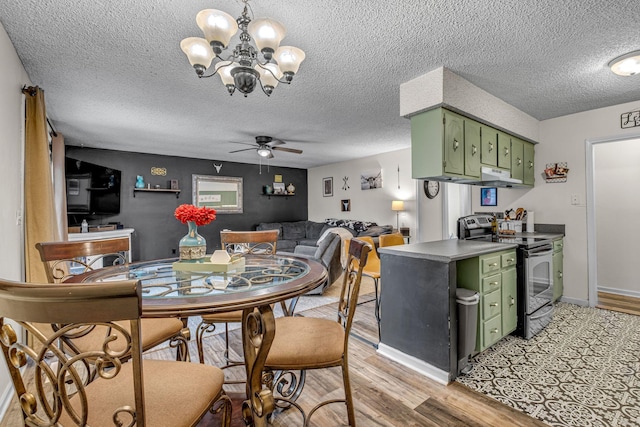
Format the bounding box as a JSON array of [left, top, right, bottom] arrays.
[[265, 238, 374, 427]]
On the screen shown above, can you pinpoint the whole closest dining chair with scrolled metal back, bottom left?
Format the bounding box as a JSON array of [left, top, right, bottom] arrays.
[[0, 279, 231, 427]]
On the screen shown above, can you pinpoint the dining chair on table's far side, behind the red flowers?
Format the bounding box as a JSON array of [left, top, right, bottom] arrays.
[[196, 230, 280, 367]]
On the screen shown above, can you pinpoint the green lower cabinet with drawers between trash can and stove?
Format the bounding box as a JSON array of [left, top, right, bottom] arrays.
[[456, 249, 518, 351]]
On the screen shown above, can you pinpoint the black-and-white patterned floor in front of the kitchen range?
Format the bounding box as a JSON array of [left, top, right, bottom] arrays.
[[456, 303, 640, 427]]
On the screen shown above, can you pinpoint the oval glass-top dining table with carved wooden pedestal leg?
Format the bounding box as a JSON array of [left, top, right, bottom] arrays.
[[67, 254, 327, 427]]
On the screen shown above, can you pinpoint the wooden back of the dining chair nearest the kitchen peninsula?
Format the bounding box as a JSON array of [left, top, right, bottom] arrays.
[[338, 238, 373, 340]]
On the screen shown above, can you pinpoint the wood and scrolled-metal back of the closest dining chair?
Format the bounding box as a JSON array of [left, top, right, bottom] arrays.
[[0, 280, 145, 426]]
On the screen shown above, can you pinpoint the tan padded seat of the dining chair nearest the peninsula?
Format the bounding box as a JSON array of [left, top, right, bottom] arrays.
[[265, 317, 344, 369]]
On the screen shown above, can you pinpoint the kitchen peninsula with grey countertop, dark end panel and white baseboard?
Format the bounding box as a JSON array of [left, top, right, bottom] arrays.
[[378, 239, 517, 384]]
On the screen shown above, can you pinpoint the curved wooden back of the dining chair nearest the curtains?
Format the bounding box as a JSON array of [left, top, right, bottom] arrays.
[[36, 237, 129, 283]]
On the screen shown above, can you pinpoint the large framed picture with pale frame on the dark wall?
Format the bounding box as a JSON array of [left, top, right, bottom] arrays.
[[191, 175, 243, 214]]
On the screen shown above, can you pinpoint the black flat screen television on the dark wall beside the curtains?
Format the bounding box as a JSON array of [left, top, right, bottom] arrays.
[[65, 157, 122, 215]]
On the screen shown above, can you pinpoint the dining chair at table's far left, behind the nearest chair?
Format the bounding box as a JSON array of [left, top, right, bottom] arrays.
[[36, 237, 190, 360]]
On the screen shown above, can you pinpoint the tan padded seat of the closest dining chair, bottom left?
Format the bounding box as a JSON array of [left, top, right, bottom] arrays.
[[60, 360, 224, 427]]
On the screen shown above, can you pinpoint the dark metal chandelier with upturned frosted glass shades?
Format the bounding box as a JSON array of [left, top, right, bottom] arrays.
[[180, 0, 305, 97]]
